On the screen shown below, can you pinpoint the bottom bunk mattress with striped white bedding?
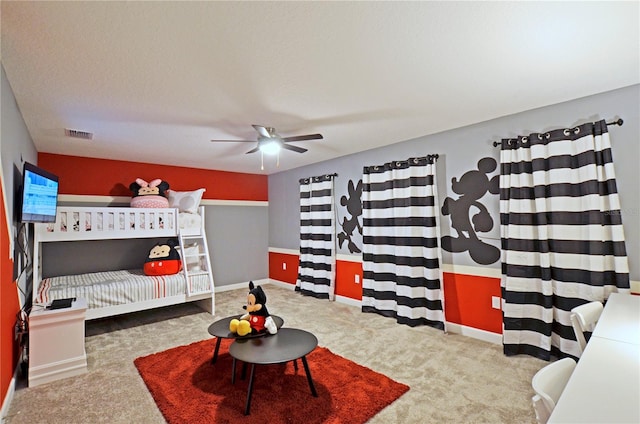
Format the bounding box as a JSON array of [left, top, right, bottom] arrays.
[[36, 269, 215, 320]]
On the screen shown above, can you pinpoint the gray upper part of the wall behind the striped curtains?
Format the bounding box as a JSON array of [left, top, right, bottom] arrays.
[[269, 85, 640, 280]]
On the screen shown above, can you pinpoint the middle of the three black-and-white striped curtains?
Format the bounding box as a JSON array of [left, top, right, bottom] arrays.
[[362, 155, 445, 330]]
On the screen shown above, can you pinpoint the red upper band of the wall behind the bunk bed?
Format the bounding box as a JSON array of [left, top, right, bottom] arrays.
[[38, 153, 268, 201]]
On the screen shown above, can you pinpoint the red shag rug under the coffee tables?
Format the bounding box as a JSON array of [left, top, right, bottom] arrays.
[[134, 339, 409, 424]]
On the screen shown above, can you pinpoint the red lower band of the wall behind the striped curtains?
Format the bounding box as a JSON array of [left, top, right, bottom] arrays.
[[269, 252, 502, 334]]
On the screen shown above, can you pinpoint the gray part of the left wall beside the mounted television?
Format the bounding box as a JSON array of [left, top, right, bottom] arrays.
[[0, 63, 38, 301]]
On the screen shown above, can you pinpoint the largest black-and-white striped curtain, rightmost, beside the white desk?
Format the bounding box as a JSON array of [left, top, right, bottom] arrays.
[[500, 121, 629, 360]]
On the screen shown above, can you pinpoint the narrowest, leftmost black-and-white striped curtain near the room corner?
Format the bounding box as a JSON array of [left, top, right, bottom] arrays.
[[295, 174, 336, 300]]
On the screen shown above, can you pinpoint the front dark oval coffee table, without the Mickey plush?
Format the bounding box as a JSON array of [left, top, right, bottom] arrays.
[[229, 328, 318, 415]]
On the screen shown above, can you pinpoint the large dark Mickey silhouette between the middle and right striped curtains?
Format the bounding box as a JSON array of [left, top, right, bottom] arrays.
[[442, 158, 500, 265]]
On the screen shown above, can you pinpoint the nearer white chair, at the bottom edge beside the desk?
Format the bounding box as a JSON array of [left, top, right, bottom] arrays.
[[531, 358, 576, 424]]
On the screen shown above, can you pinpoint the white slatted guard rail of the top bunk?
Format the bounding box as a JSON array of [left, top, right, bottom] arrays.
[[34, 206, 204, 243]]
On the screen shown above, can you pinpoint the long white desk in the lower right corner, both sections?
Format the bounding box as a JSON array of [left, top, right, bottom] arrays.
[[549, 293, 640, 424]]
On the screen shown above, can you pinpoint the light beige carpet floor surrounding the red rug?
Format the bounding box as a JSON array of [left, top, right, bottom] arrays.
[[6, 284, 547, 424]]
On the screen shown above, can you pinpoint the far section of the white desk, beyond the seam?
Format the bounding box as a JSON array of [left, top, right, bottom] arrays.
[[591, 293, 640, 344]]
